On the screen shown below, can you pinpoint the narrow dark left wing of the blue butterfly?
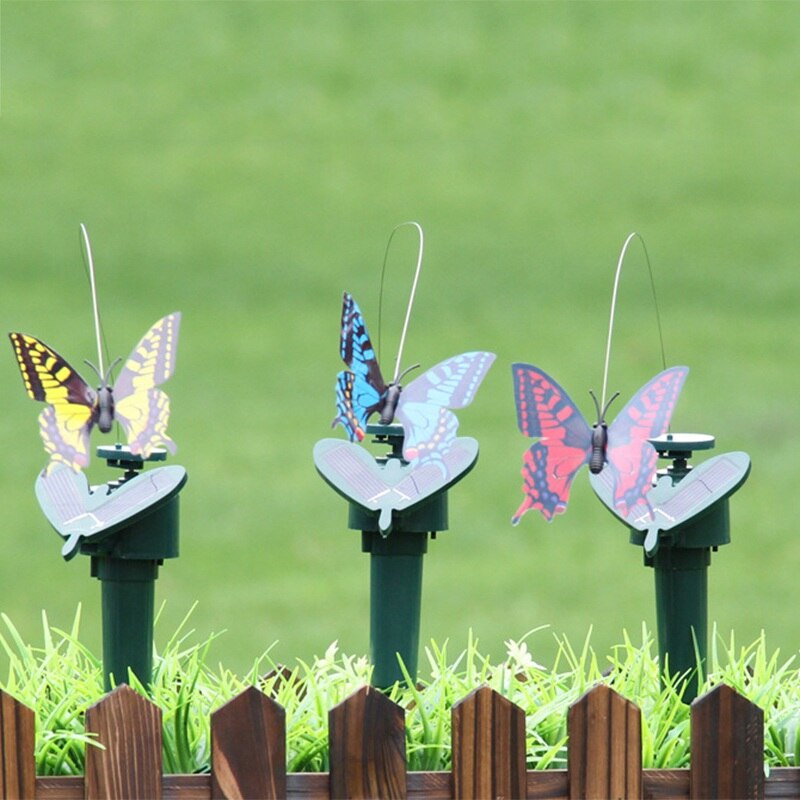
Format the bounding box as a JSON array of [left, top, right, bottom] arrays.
[[333, 292, 386, 441]]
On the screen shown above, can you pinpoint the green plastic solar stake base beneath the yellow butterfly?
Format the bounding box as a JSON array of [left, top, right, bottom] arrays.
[[36, 445, 187, 690]]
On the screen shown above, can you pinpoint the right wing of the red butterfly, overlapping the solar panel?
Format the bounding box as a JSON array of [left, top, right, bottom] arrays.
[[606, 367, 689, 517]]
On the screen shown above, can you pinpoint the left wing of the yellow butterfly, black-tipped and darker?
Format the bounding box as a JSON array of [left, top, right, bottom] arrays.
[[9, 333, 97, 471]]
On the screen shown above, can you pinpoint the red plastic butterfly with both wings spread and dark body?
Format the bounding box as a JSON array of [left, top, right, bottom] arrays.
[[511, 364, 689, 525]]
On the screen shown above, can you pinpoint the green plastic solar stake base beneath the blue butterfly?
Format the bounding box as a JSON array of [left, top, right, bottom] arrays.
[[314, 425, 478, 689]]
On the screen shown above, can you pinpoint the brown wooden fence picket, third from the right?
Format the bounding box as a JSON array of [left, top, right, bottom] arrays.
[[452, 686, 527, 800]]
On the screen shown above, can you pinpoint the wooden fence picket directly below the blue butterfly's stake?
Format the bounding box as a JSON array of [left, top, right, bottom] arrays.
[[328, 686, 407, 798]]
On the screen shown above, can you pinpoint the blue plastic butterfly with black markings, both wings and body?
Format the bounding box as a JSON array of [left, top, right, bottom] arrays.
[[333, 292, 495, 463]]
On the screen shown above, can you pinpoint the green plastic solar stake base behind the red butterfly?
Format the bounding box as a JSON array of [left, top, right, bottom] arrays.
[[592, 434, 750, 702]]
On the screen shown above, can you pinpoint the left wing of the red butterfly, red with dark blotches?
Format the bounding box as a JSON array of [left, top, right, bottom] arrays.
[[511, 364, 592, 525]]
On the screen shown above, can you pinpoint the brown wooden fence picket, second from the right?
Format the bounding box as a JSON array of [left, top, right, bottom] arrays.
[[567, 684, 642, 800]]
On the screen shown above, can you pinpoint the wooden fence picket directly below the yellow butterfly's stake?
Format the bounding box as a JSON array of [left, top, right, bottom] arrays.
[[85, 684, 162, 800]]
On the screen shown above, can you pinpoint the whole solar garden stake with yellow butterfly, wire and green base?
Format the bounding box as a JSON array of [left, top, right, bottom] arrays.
[[10, 225, 187, 688]]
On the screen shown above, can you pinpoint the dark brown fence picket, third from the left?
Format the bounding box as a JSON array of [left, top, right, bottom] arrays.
[[211, 686, 286, 800]]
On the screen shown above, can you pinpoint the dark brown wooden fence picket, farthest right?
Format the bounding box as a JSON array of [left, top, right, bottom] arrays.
[[689, 684, 764, 800]]
